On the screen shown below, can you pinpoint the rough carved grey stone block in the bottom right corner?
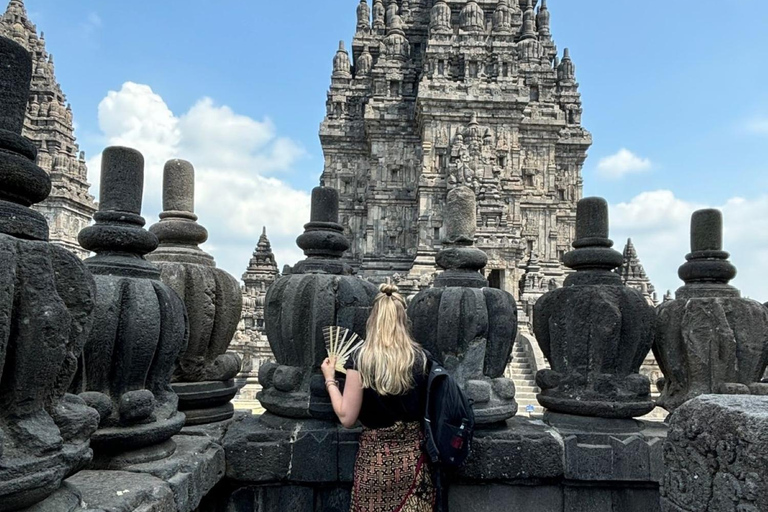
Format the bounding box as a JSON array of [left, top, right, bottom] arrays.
[[662, 395, 768, 512]]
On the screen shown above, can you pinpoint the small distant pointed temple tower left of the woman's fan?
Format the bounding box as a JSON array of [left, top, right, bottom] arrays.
[[230, 227, 280, 404]]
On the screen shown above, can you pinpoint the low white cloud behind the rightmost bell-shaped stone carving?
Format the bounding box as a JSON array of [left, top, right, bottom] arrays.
[[611, 190, 768, 302]]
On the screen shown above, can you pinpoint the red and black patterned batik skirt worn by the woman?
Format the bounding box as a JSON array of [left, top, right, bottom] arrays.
[[350, 422, 435, 512]]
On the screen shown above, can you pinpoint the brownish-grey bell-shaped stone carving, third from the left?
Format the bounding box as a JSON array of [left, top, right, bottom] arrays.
[[147, 160, 243, 425]]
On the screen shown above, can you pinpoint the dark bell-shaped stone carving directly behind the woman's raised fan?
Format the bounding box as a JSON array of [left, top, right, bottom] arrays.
[[258, 187, 378, 419]]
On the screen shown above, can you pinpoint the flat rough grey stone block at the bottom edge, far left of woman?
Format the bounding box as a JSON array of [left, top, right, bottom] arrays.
[[67, 471, 176, 512]]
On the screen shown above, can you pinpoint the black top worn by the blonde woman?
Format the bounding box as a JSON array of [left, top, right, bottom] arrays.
[[344, 352, 428, 429]]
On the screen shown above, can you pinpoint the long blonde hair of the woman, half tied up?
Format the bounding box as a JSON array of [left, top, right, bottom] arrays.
[[357, 284, 426, 395]]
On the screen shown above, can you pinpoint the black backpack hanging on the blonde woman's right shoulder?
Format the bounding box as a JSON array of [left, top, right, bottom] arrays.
[[424, 357, 475, 469]]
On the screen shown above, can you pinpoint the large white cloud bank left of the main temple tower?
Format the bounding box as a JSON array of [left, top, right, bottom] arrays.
[[88, 82, 309, 278]]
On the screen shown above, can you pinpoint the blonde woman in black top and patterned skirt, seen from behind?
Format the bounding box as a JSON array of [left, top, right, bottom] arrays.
[[322, 284, 435, 512]]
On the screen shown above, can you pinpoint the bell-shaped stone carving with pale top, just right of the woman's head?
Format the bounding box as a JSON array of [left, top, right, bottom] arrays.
[[408, 186, 517, 424]]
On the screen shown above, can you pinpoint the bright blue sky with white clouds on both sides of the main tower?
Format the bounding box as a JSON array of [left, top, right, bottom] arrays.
[[18, 0, 768, 300]]
